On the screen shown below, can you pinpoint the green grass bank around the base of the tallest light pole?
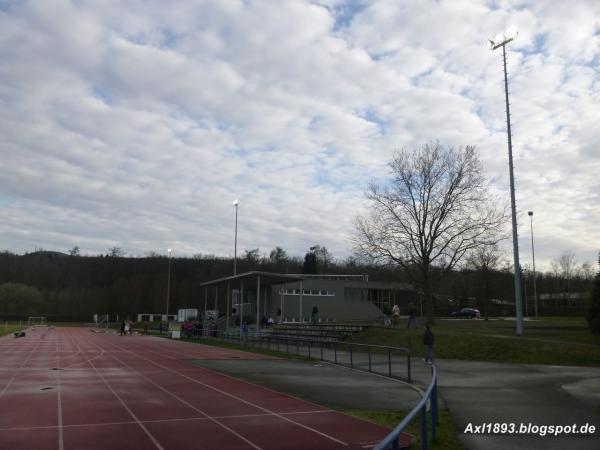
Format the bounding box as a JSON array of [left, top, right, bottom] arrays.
[[351, 317, 600, 367]]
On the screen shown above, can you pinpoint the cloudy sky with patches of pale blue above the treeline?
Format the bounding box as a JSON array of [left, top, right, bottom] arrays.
[[0, 0, 600, 270]]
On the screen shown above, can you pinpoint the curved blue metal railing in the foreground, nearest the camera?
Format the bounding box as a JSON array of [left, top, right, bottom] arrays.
[[373, 365, 438, 450]]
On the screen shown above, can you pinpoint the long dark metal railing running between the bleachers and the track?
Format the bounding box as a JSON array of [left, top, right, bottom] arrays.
[[182, 330, 412, 383]]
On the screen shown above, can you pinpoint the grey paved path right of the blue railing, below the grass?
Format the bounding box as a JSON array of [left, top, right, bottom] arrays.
[[413, 360, 600, 450]]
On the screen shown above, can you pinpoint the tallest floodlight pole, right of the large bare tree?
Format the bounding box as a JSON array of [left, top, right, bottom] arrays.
[[489, 25, 523, 334]]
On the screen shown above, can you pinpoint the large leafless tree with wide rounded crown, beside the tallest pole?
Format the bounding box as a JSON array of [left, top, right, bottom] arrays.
[[354, 143, 508, 322]]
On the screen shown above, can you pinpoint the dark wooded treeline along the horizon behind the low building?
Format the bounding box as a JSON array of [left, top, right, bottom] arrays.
[[0, 246, 591, 320]]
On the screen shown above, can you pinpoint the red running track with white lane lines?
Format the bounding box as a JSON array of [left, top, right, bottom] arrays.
[[0, 327, 398, 450]]
